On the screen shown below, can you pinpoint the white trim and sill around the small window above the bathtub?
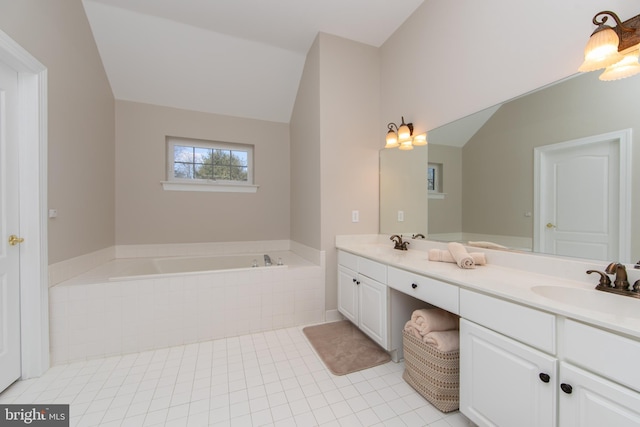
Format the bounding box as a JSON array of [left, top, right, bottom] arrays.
[[160, 136, 259, 193]]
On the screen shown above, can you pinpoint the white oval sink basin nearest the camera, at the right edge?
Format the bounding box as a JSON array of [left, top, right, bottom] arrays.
[[531, 286, 640, 319]]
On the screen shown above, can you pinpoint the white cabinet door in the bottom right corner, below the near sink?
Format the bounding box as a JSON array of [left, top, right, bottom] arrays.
[[559, 360, 640, 427]]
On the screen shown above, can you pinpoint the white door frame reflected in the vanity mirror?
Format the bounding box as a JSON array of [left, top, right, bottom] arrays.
[[533, 128, 632, 263]]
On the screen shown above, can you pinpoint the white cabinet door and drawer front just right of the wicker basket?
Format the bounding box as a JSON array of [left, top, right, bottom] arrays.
[[460, 289, 558, 427]]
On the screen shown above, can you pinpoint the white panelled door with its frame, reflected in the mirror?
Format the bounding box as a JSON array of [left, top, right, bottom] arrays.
[[534, 132, 630, 262]]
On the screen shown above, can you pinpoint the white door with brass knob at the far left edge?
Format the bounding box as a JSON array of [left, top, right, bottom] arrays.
[[0, 63, 21, 391]]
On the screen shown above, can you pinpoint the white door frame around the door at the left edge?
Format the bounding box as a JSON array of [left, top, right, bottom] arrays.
[[0, 30, 49, 379]]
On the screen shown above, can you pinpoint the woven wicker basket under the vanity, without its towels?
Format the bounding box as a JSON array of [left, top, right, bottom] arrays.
[[402, 331, 460, 412]]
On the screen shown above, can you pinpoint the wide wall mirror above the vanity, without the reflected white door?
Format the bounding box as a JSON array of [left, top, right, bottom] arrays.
[[380, 73, 640, 262]]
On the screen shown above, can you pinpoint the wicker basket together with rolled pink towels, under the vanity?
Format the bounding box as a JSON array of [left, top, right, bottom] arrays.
[[402, 308, 460, 412]]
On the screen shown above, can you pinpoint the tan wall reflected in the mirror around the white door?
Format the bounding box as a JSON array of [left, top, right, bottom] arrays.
[[462, 73, 640, 260]]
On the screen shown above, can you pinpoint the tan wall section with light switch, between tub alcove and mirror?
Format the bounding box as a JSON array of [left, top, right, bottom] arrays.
[[320, 34, 384, 309]]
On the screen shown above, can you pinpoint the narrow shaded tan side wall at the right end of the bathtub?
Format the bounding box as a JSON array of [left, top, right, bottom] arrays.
[[289, 37, 321, 249]]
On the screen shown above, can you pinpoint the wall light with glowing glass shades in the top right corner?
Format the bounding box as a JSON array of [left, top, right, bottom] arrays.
[[578, 10, 640, 81]]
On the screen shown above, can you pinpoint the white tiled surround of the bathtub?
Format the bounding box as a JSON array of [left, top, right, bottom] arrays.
[[49, 246, 325, 365]]
